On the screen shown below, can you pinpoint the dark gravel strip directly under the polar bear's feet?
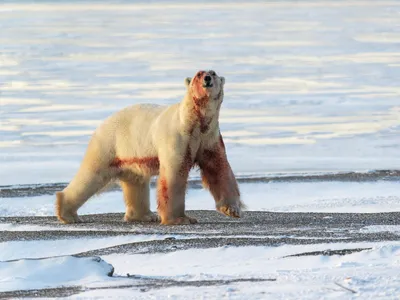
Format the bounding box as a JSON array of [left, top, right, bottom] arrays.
[[0, 211, 400, 248]]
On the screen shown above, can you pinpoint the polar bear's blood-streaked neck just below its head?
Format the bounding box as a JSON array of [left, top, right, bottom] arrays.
[[180, 92, 223, 136]]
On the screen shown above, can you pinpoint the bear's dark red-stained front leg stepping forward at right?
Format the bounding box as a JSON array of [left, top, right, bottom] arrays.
[[199, 136, 244, 218]]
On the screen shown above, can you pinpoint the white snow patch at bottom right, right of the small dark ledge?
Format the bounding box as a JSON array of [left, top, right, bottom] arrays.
[[92, 243, 400, 299]]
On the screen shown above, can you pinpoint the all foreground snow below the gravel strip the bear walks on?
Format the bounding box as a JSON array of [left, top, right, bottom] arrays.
[[0, 238, 400, 299]]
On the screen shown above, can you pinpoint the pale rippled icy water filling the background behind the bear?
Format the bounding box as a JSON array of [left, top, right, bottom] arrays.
[[0, 1, 400, 185]]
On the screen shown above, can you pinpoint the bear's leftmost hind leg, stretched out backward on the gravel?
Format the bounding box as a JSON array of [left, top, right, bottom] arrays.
[[56, 166, 111, 224]]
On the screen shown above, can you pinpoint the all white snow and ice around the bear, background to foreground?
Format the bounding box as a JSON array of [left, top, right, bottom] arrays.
[[0, 0, 400, 299]]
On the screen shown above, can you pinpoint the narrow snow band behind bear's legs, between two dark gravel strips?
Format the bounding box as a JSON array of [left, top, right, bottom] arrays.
[[0, 181, 400, 217]]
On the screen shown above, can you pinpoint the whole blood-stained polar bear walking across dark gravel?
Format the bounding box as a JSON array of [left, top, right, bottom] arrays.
[[56, 70, 244, 225]]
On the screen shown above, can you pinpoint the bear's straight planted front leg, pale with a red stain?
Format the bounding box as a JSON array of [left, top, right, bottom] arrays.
[[157, 158, 197, 225]]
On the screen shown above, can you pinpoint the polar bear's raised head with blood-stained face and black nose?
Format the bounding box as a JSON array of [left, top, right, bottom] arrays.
[[185, 70, 225, 105]]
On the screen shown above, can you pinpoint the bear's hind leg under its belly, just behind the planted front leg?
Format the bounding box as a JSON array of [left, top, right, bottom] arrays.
[[121, 179, 159, 222]]
